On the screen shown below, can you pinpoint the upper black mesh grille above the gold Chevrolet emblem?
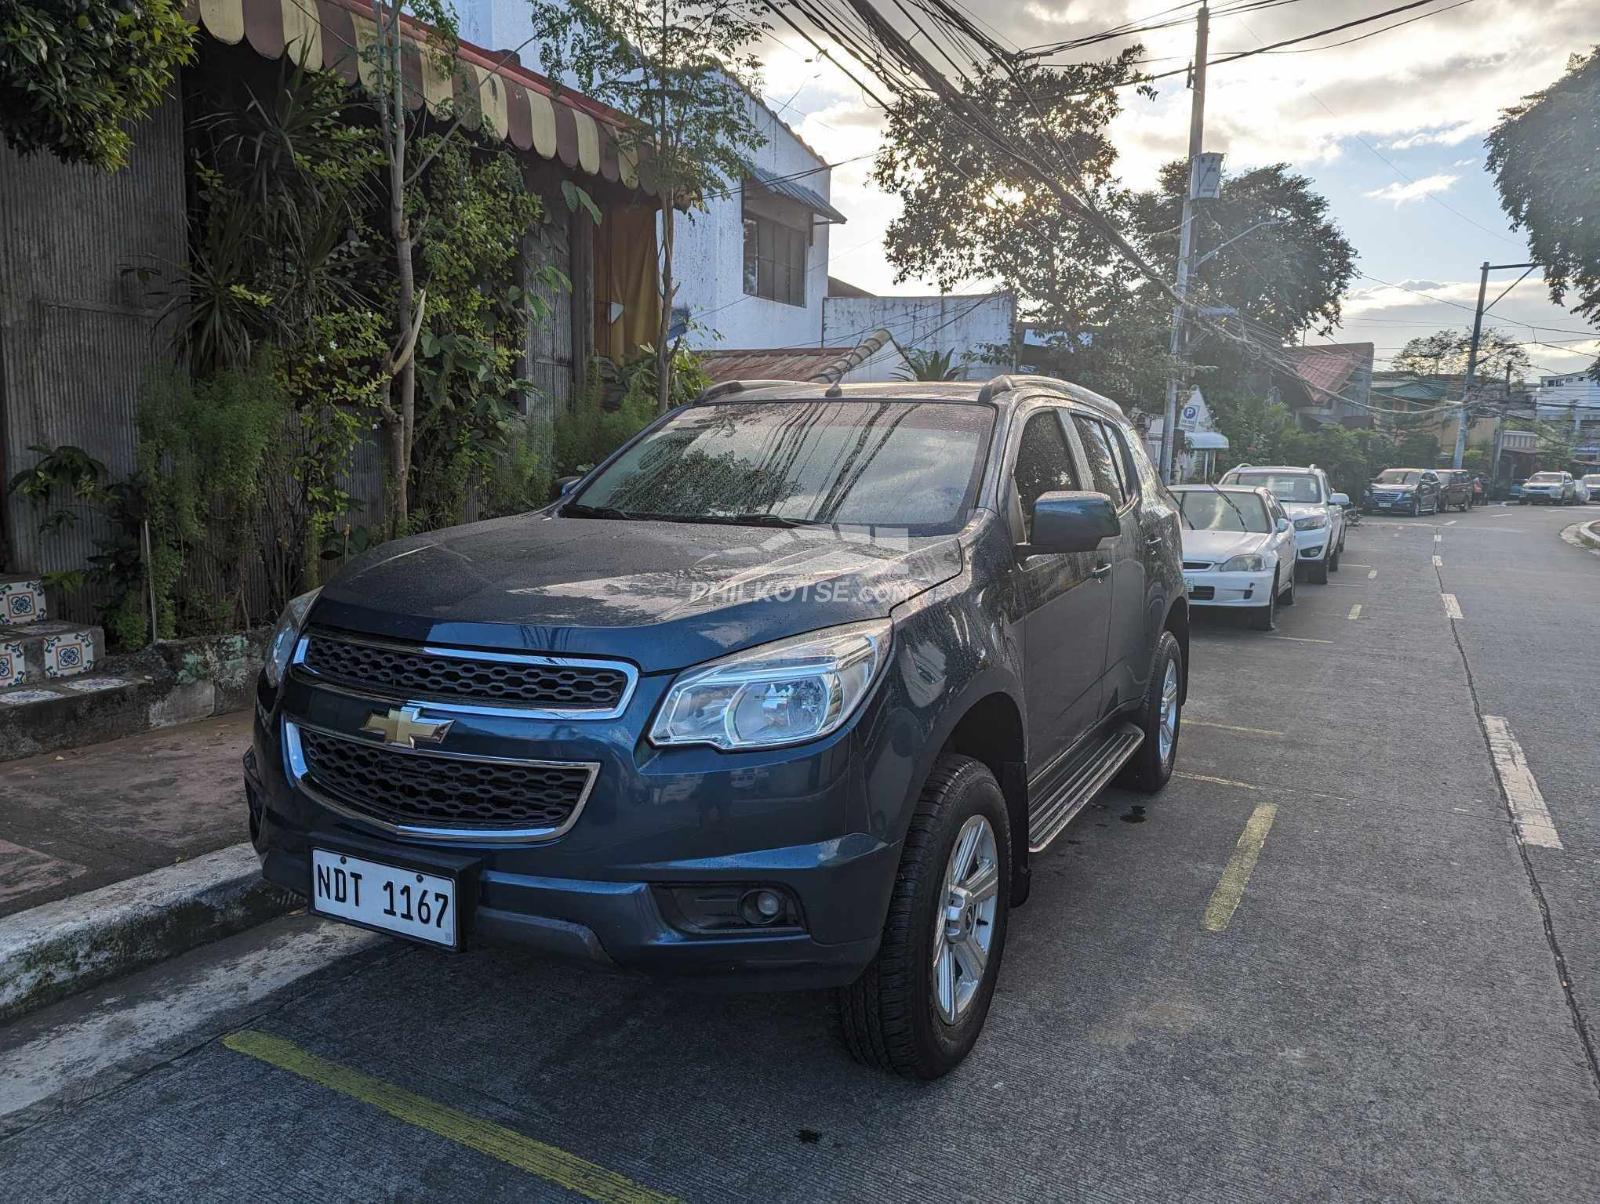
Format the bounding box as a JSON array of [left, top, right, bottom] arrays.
[[301, 632, 629, 711]]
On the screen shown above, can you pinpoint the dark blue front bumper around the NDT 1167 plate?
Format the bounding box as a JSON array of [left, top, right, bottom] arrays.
[[245, 669, 901, 989]]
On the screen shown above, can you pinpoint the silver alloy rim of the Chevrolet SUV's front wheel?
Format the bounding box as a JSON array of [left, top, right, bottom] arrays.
[[933, 815, 1000, 1025]]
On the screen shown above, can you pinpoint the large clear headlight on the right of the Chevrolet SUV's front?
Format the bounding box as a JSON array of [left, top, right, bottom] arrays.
[[650, 618, 894, 748]]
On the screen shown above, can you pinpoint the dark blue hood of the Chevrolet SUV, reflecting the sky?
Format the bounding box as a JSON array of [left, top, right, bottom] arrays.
[[310, 512, 962, 672]]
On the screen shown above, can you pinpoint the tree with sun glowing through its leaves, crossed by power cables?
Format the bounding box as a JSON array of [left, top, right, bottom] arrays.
[[874, 46, 1171, 399]]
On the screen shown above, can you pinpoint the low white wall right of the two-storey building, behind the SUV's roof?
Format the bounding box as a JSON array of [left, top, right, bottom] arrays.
[[822, 293, 1016, 379]]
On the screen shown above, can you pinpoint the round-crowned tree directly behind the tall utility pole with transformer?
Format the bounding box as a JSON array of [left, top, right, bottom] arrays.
[[1131, 160, 1355, 346]]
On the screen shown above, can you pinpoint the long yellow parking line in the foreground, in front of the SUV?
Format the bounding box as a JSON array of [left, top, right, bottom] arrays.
[[222, 1029, 675, 1204]]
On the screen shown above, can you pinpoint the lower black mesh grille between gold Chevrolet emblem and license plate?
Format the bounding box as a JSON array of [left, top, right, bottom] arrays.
[[299, 728, 595, 833]]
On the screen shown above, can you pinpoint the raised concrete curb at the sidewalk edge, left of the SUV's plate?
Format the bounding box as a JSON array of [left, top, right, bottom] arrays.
[[0, 844, 302, 1021]]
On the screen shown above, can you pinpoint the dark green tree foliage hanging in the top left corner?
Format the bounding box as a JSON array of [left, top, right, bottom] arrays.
[[0, 0, 195, 171]]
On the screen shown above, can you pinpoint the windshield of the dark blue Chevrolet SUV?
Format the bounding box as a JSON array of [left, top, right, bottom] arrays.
[[562, 400, 994, 535]]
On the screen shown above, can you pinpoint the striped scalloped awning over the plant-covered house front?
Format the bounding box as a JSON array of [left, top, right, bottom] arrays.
[[189, 0, 638, 187]]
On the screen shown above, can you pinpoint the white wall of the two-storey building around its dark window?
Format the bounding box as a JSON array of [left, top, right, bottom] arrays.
[[456, 0, 830, 351]]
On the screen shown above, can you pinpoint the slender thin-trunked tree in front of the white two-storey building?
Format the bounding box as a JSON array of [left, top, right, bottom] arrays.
[[533, 0, 768, 410]]
